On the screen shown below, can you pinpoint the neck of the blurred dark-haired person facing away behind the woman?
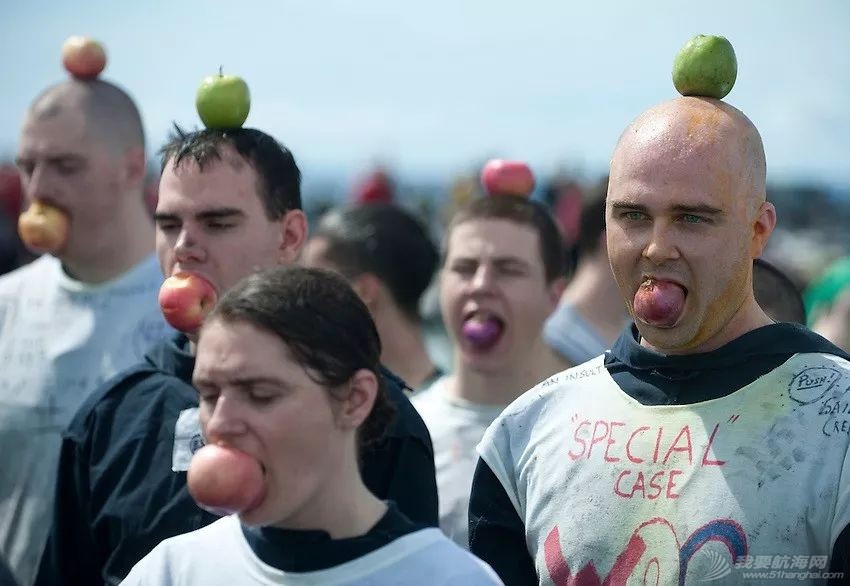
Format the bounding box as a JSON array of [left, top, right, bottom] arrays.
[[373, 307, 434, 389]]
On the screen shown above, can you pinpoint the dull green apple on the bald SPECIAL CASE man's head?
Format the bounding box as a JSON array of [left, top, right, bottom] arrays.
[[673, 35, 738, 100]]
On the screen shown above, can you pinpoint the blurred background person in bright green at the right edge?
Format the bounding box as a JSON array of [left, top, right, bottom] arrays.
[[803, 257, 850, 351]]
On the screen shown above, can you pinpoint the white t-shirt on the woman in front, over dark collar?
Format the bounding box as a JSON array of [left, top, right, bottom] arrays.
[[121, 515, 502, 586]]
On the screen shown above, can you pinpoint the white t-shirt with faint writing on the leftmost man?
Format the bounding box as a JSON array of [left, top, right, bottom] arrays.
[[0, 255, 170, 585]]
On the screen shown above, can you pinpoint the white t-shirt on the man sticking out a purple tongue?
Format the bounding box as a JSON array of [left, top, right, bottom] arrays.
[[411, 376, 505, 549]]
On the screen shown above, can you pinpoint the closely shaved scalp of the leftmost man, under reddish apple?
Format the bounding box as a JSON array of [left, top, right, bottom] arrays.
[[27, 79, 145, 152]]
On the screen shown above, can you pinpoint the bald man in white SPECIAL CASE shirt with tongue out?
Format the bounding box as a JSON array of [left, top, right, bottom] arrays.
[[470, 98, 850, 586]]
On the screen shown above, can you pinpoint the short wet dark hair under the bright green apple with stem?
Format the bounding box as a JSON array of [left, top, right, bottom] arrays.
[[159, 124, 301, 220]]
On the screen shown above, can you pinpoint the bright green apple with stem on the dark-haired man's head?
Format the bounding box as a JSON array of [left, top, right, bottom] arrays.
[[195, 71, 251, 130]]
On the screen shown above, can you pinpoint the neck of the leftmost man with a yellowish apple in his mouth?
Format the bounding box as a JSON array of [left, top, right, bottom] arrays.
[[60, 194, 155, 284]]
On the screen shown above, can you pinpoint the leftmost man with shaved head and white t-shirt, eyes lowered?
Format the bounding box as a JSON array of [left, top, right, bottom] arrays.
[[0, 80, 168, 586]]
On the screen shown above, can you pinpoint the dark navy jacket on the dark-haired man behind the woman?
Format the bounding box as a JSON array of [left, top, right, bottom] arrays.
[[36, 334, 438, 586]]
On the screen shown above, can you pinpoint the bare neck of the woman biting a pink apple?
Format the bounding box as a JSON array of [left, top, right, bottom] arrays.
[[278, 448, 387, 539]]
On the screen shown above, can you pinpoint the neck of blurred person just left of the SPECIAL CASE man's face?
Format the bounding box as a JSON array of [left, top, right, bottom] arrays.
[[561, 253, 627, 344]]
